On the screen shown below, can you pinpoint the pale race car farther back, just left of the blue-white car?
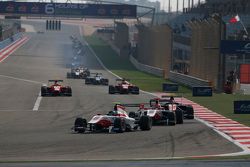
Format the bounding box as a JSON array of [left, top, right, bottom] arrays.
[[67, 67, 90, 79]]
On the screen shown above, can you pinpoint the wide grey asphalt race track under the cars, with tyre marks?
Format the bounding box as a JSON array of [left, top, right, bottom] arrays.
[[0, 21, 241, 161]]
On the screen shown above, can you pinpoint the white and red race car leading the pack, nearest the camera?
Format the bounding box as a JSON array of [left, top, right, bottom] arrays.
[[72, 104, 152, 133]]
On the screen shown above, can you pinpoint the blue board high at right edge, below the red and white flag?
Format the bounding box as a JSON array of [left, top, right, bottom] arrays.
[[220, 40, 250, 54]]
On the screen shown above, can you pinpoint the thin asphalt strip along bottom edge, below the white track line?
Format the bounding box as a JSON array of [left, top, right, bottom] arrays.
[[0, 160, 250, 167]]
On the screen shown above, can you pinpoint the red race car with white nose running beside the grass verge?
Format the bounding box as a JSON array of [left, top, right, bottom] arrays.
[[109, 79, 140, 95]]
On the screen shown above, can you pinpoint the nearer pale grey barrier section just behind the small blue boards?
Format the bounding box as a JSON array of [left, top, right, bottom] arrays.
[[169, 71, 211, 87]]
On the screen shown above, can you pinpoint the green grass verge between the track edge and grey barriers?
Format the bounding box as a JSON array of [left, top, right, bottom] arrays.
[[85, 35, 250, 126]]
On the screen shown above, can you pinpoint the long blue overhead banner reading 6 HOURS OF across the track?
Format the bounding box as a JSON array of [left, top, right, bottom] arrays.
[[0, 1, 137, 18]]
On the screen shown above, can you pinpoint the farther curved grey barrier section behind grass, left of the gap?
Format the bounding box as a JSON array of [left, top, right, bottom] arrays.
[[129, 55, 164, 77]]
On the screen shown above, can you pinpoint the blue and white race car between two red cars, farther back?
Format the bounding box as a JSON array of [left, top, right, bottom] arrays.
[[85, 73, 109, 85]]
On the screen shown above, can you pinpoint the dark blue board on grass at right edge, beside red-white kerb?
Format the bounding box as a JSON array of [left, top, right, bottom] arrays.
[[234, 100, 250, 114]]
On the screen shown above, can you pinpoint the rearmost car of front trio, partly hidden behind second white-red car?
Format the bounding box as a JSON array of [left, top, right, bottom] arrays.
[[149, 96, 194, 119]]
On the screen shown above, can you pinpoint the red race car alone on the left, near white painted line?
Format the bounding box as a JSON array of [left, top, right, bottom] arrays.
[[41, 80, 72, 96]]
